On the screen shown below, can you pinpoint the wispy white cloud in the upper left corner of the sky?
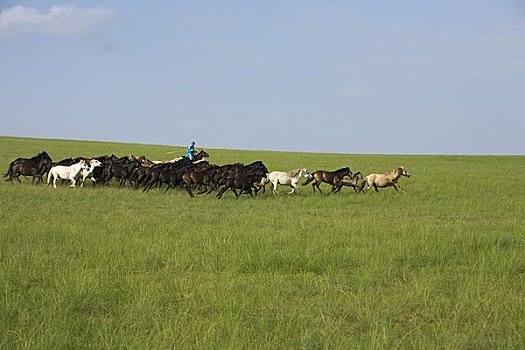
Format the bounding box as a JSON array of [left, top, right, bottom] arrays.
[[0, 5, 114, 37]]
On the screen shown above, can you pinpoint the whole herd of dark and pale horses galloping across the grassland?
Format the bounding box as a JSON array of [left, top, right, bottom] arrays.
[[4, 150, 410, 199]]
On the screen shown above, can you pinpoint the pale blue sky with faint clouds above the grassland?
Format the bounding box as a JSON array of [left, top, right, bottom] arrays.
[[0, 0, 525, 155]]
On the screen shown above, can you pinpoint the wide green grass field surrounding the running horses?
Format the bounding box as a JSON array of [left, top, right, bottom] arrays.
[[0, 137, 525, 349]]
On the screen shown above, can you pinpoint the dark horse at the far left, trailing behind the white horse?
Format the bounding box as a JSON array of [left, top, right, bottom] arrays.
[[4, 151, 53, 184]]
